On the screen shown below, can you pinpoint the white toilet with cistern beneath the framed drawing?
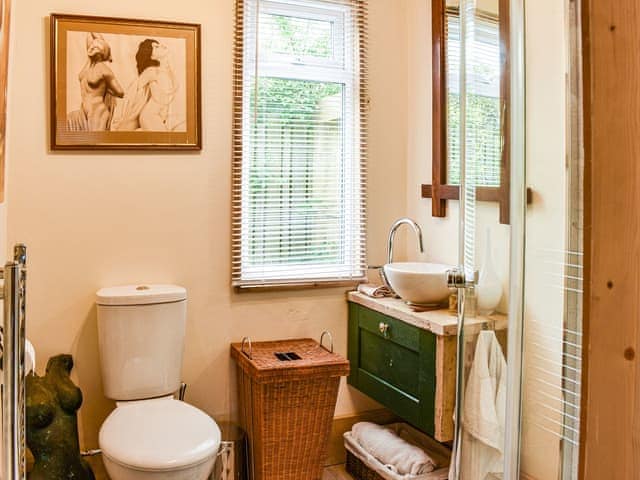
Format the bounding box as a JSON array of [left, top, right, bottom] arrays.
[[96, 285, 221, 480]]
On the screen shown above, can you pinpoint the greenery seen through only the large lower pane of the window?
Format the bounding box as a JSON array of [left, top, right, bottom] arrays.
[[249, 78, 343, 264]]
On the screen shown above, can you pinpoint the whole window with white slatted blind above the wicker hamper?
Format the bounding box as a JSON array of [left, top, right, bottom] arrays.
[[232, 0, 366, 288]]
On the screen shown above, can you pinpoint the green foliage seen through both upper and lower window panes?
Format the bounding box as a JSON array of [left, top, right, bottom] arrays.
[[246, 13, 344, 266]]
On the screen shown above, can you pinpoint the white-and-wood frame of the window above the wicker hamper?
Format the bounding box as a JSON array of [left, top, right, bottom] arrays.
[[232, 0, 369, 286]]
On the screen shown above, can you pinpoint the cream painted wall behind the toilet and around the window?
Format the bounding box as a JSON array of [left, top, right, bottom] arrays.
[[8, 0, 407, 448]]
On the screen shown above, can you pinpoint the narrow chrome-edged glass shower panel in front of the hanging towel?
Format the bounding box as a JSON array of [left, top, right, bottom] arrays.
[[449, 0, 510, 480]]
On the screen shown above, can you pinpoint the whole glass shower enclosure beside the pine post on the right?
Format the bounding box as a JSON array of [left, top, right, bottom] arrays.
[[445, 0, 584, 480]]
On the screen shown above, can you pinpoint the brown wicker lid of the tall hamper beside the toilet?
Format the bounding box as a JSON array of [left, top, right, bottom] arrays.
[[231, 338, 349, 383]]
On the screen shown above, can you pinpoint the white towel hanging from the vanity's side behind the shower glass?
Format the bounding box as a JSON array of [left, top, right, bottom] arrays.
[[452, 331, 507, 480]]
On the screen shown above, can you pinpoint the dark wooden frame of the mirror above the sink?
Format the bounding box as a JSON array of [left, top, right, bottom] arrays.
[[422, 0, 511, 224]]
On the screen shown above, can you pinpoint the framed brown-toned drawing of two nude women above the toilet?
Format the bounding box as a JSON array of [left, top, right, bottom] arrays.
[[51, 14, 202, 150]]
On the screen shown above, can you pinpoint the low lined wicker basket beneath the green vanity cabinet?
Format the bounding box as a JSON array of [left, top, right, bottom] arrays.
[[344, 423, 451, 480]]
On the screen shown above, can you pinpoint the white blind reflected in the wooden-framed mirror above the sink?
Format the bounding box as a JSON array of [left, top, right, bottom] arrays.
[[445, 8, 502, 187]]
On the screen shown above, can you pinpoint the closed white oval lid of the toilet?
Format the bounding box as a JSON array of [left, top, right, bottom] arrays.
[[99, 398, 220, 470]]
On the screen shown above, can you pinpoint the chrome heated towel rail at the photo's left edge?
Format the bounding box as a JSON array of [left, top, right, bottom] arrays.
[[1, 245, 27, 480]]
